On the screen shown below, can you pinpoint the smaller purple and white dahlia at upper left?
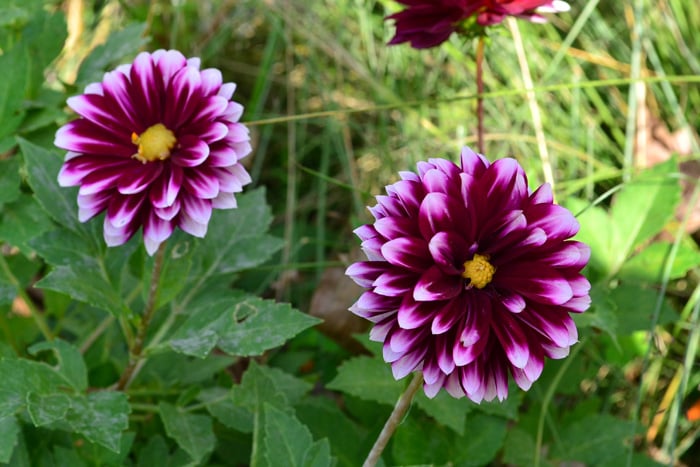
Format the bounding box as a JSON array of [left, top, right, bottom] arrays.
[[55, 50, 251, 255]]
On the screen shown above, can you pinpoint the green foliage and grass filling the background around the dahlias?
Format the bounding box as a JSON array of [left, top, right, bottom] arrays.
[[0, 0, 700, 467]]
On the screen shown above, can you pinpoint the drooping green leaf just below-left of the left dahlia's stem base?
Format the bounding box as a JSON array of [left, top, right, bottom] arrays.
[[66, 391, 131, 453]]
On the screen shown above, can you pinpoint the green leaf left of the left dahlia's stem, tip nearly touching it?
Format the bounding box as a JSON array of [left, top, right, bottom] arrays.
[[36, 256, 129, 316]]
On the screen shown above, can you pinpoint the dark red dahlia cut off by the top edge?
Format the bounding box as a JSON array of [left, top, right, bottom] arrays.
[[387, 0, 569, 49]]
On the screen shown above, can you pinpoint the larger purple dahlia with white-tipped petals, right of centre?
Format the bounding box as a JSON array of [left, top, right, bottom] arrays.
[[347, 148, 591, 402]]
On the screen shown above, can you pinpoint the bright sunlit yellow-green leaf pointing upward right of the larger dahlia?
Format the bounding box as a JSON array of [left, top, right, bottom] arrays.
[[610, 159, 681, 271]]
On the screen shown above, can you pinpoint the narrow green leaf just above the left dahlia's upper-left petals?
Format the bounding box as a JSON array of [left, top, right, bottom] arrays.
[[76, 23, 148, 87]]
